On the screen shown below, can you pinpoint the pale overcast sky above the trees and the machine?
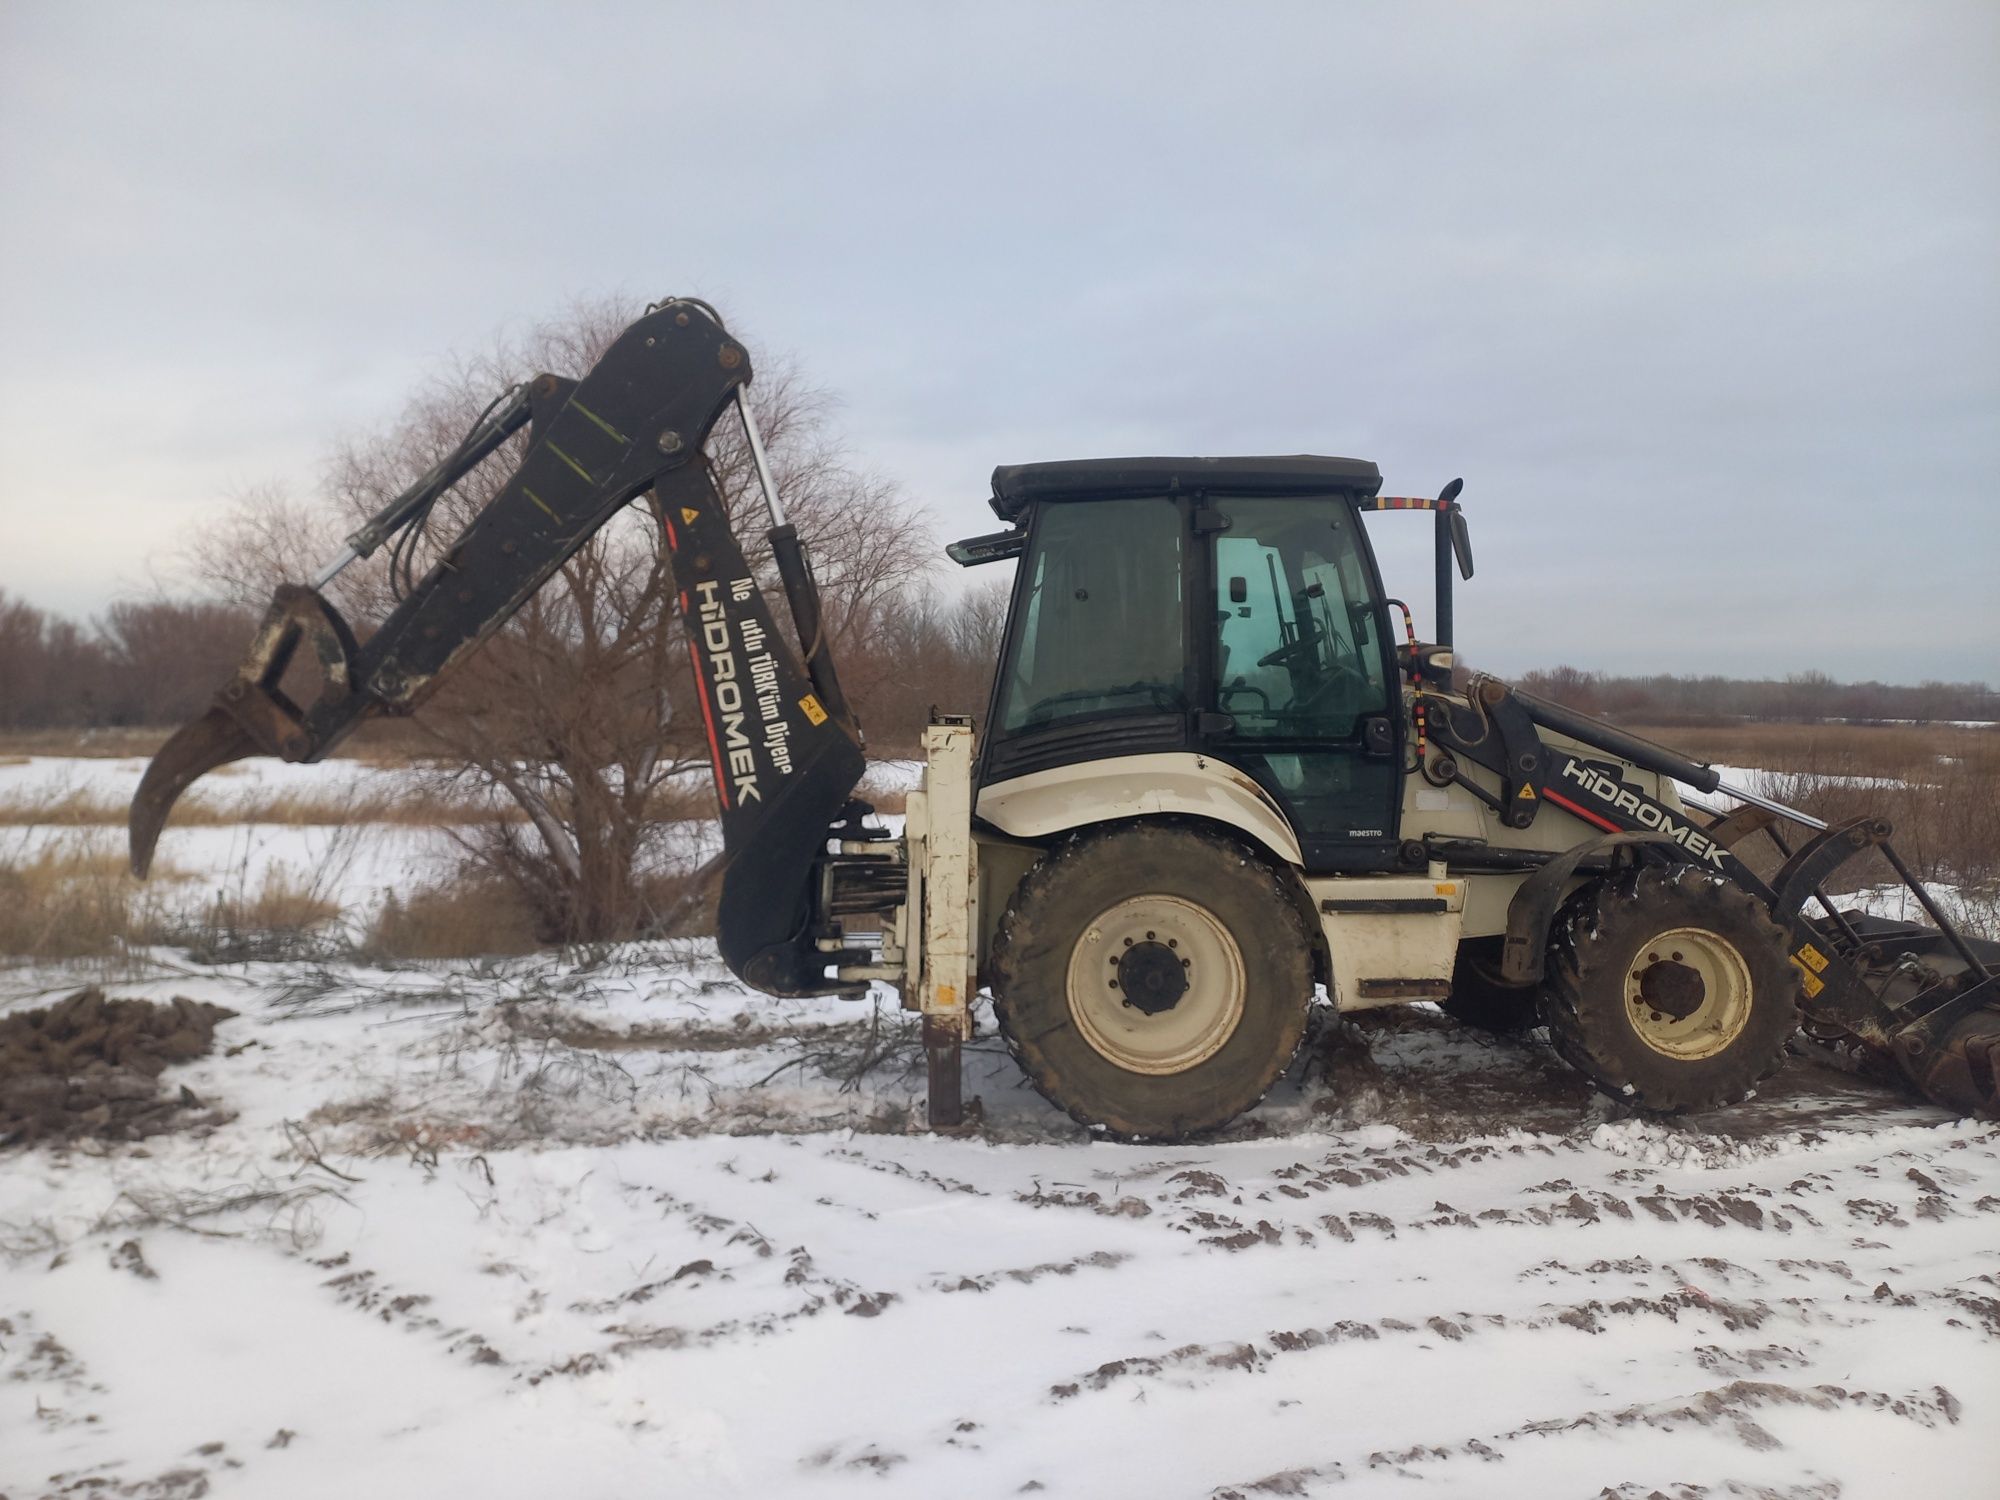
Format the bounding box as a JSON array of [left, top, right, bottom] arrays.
[[0, 0, 2000, 682]]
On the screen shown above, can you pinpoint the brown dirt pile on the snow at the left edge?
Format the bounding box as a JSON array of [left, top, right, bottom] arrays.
[[0, 986, 236, 1146]]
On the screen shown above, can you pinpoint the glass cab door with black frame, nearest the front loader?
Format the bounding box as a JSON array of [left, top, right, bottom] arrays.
[[1202, 496, 1402, 872]]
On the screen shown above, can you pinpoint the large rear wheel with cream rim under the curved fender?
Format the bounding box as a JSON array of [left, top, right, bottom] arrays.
[[992, 824, 1312, 1140]]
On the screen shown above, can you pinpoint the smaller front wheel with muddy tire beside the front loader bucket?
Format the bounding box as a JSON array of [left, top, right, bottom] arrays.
[[1542, 866, 1798, 1114]]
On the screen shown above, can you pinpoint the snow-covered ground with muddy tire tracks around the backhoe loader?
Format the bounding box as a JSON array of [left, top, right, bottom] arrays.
[[0, 756, 2000, 1500]]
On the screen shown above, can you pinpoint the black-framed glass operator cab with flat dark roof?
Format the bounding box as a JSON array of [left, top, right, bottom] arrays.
[[952, 456, 1404, 872]]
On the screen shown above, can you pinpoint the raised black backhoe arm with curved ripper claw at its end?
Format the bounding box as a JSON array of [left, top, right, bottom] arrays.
[[130, 300, 864, 992]]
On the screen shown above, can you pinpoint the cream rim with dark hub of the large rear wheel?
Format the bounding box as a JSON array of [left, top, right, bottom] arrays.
[[1068, 896, 1246, 1076]]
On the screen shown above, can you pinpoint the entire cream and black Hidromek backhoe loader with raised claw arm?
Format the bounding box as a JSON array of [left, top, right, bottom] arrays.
[[130, 298, 2000, 1140]]
